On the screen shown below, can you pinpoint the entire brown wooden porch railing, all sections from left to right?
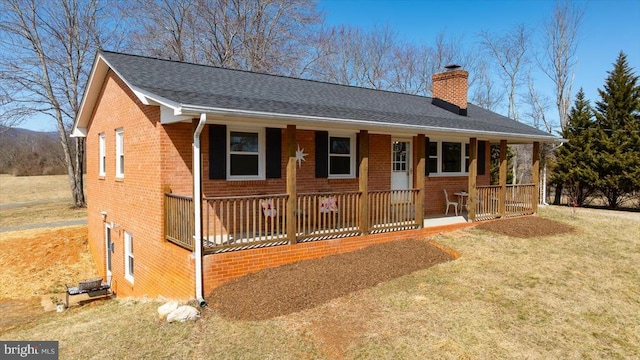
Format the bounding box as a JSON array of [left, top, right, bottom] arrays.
[[165, 184, 535, 253]]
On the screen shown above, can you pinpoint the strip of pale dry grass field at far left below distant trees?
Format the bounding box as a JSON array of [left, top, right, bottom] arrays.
[[0, 174, 71, 204]]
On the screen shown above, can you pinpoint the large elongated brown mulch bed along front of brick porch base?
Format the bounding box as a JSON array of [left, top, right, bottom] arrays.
[[207, 240, 453, 320]]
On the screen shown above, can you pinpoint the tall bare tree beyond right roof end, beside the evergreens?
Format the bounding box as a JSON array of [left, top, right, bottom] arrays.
[[538, 0, 584, 129]]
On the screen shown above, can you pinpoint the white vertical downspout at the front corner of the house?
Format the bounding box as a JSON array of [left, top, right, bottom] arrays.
[[193, 113, 207, 307]]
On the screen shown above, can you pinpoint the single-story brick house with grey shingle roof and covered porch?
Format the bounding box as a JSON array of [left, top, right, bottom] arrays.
[[72, 51, 557, 301]]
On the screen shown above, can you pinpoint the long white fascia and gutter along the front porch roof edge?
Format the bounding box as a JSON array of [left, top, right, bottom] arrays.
[[181, 105, 560, 143]]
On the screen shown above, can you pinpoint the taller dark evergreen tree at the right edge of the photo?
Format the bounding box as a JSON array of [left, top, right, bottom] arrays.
[[595, 52, 640, 209]]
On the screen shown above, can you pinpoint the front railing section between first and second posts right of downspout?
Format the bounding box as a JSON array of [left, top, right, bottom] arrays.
[[295, 191, 362, 242]]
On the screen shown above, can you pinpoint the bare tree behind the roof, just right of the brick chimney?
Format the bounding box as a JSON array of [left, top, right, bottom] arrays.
[[480, 25, 530, 121]]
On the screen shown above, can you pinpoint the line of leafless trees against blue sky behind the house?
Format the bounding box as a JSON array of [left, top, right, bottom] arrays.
[[0, 0, 584, 206]]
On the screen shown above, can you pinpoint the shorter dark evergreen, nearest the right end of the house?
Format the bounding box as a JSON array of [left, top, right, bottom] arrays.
[[552, 89, 598, 206]]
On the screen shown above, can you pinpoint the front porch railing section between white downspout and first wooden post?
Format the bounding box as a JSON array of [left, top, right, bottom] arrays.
[[202, 194, 288, 253]]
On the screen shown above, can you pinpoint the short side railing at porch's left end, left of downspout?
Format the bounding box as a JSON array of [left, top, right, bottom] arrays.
[[164, 194, 195, 250]]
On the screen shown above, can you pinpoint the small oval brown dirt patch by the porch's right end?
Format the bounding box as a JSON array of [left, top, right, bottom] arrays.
[[476, 216, 575, 239]]
